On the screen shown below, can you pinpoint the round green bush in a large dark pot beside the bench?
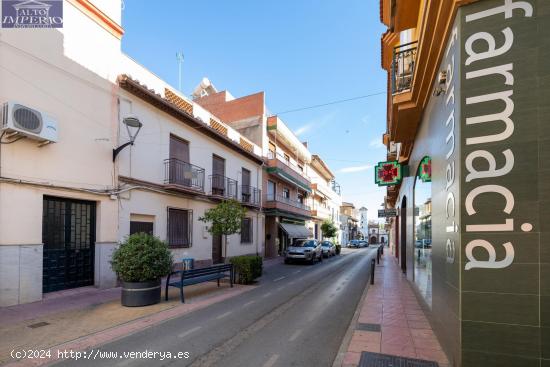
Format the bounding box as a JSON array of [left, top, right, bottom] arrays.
[[111, 233, 172, 307]]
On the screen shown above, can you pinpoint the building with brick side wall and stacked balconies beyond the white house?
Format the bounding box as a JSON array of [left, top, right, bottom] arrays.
[[194, 80, 313, 257]]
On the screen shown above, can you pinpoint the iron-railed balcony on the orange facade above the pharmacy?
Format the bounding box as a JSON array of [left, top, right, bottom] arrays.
[[391, 41, 418, 94]]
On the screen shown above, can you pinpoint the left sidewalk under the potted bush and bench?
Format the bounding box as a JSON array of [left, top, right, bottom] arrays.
[[0, 282, 254, 366]]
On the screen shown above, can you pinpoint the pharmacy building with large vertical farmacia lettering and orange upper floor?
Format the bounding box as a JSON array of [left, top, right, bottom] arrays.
[[377, 0, 550, 367]]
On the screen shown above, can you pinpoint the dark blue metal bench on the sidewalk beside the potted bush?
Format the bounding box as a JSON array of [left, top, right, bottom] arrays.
[[164, 264, 233, 303]]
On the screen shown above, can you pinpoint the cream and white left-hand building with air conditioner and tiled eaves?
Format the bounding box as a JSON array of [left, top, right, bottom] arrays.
[[0, 0, 266, 306]]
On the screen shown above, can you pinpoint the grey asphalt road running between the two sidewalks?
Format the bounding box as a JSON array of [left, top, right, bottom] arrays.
[[56, 248, 376, 367]]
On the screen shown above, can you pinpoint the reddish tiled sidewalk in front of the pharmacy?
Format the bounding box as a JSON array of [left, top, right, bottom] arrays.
[[342, 249, 450, 367]]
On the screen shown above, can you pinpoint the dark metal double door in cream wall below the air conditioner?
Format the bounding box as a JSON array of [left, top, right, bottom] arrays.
[[42, 196, 96, 293]]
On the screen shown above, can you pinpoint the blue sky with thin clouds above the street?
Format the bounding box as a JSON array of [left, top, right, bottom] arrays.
[[122, 0, 386, 219]]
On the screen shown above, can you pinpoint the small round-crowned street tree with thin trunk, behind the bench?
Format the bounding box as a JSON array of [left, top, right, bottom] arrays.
[[199, 199, 246, 264]]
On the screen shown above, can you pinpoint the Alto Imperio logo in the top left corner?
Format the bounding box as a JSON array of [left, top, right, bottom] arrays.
[[0, 0, 63, 28]]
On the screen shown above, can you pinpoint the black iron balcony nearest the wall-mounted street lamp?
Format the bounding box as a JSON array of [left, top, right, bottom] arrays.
[[164, 158, 204, 192]]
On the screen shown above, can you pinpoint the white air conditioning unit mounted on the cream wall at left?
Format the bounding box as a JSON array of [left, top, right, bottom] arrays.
[[0, 102, 58, 143]]
